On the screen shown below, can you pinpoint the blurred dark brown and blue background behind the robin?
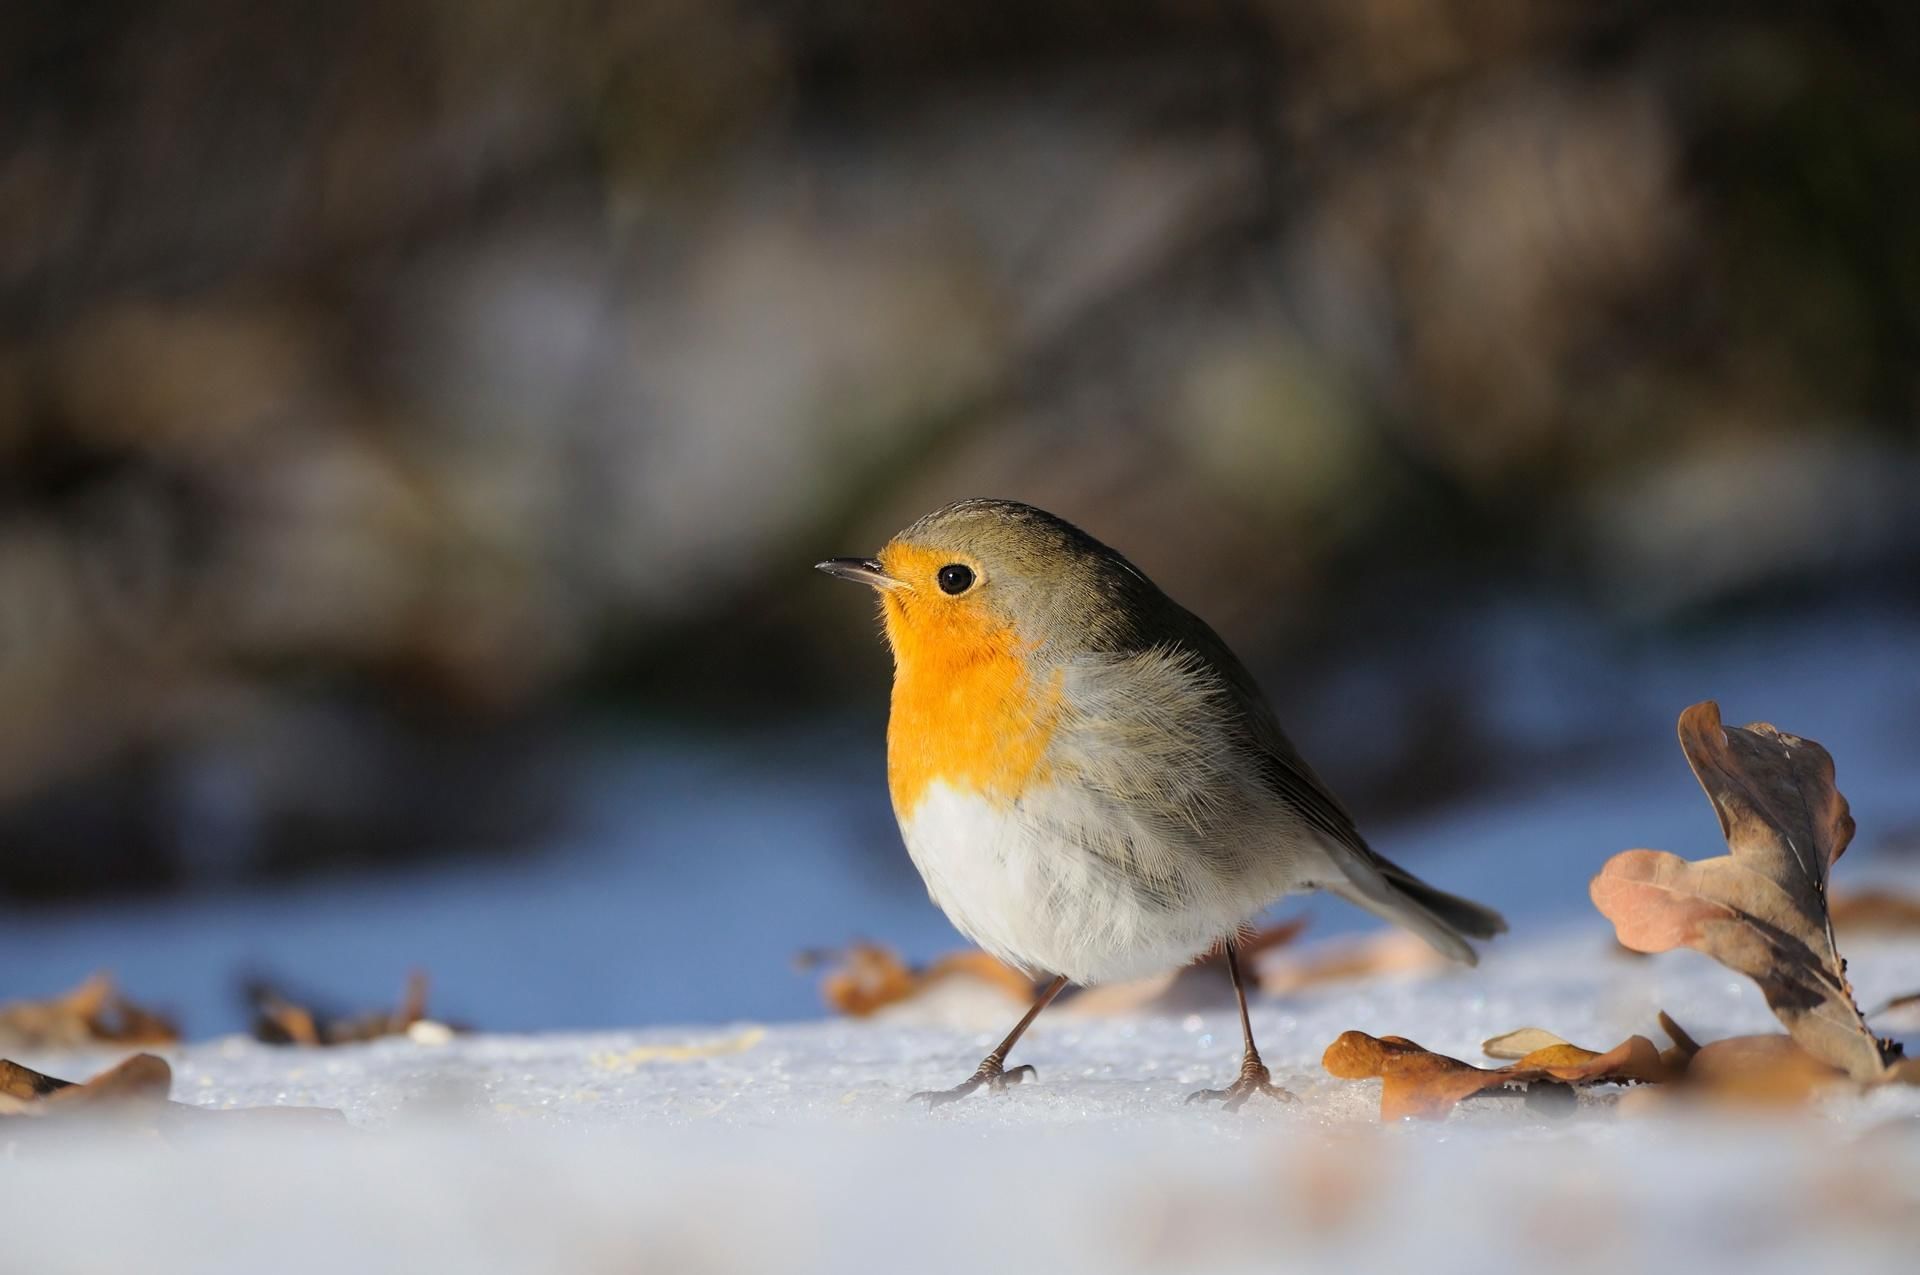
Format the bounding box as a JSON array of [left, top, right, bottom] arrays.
[[0, 0, 1920, 1035]]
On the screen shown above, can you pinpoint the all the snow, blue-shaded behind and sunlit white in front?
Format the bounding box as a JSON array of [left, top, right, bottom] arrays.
[[11, 610, 1920, 1275]]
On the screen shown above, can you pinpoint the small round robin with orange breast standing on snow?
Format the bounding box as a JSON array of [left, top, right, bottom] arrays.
[[816, 499, 1507, 1110]]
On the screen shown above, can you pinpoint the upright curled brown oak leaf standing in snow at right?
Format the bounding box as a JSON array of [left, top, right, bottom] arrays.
[[1588, 701, 1897, 1081]]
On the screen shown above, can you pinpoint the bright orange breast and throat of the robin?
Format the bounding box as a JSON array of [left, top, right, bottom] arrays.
[[885, 576, 1060, 820]]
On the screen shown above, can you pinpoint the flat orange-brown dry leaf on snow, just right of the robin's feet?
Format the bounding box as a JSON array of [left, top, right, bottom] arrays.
[[1321, 1031, 1670, 1119]]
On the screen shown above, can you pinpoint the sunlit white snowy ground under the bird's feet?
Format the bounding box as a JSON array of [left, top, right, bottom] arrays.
[[0, 926, 1920, 1273]]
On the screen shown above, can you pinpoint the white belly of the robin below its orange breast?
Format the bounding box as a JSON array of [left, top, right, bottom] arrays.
[[900, 783, 1286, 983]]
